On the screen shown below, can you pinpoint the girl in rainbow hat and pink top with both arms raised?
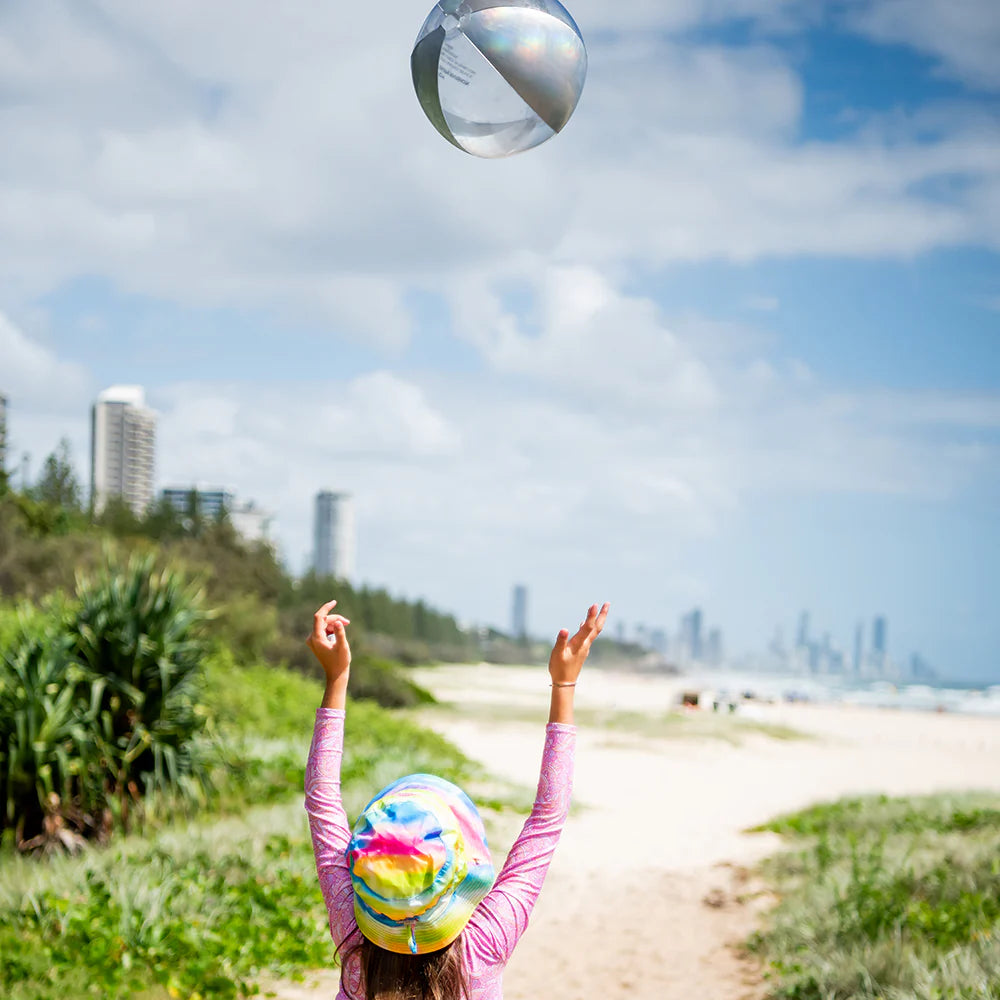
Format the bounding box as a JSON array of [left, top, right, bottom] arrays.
[[305, 601, 608, 1000]]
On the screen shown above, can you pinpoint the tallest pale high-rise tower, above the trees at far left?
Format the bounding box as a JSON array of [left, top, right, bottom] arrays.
[[90, 385, 156, 514]]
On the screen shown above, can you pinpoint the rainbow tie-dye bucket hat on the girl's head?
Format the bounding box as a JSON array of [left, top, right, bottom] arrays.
[[347, 774, 496, 955]]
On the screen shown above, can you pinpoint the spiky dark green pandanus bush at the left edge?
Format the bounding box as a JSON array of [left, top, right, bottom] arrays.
[[0, 557, 211, 849]]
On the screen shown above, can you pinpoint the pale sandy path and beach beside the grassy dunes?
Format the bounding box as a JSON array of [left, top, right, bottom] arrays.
[[266, 667, 1000, 1000]]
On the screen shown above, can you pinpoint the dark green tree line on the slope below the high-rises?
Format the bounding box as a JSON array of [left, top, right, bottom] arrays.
[[0, 441, 477, 668]]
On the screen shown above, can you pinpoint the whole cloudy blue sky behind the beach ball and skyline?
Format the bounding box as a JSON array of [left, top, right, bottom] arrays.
[[0, 0, 1000, 678]]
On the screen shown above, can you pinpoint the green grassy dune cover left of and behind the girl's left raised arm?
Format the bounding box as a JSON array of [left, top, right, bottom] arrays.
[[0, 657, 484, 1000]]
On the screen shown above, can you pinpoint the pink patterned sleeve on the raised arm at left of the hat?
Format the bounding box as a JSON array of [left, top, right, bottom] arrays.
[[306, 708, 357, 946]]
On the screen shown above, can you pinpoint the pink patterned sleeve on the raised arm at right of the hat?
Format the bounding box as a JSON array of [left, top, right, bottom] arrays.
[[465, 722, 576, 964]]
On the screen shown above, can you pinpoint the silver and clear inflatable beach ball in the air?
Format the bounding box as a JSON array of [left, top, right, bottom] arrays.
[[410, 0, 587, 157]]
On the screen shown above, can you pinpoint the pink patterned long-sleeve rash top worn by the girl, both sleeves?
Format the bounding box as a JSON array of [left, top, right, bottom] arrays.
[[306, 708, 576, 1000]]
